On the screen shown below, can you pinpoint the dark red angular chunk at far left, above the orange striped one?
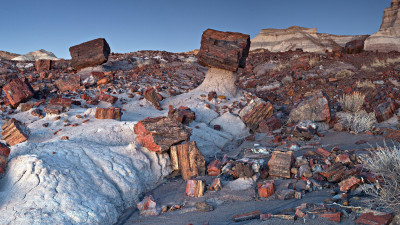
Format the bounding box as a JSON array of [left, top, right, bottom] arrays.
[[3, 78, 34, 107]]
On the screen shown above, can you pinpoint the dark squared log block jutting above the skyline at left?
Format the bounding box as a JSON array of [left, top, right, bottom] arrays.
[[69, 38, 110, 70]]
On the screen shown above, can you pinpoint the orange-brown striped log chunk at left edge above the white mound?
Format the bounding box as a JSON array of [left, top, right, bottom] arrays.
[[1, 118, 29, 146]]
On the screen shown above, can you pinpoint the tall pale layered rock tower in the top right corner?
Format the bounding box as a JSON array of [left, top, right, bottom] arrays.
[[364, 0, 400, 52]]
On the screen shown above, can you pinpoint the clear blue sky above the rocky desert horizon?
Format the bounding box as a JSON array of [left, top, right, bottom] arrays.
[[0, 0, 391, 58]]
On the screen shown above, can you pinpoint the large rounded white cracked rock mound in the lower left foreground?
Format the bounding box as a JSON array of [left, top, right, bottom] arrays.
[[0, 120, 170, 224]]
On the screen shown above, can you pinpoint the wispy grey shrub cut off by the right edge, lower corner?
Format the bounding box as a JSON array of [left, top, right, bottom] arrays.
[[363, 144, 400, 213]]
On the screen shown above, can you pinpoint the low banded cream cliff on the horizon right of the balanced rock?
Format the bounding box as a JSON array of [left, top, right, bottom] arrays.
[[250, 26, 368, 52]]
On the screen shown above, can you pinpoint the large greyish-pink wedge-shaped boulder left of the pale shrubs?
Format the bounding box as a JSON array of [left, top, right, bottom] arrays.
[[289, 91, 331, 122]]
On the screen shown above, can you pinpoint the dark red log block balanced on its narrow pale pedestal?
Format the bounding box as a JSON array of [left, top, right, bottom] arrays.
[[195, 29, 250, 97]]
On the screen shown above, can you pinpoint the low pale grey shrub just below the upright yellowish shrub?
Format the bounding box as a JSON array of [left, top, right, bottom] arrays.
[[338, 110, 376, 134]]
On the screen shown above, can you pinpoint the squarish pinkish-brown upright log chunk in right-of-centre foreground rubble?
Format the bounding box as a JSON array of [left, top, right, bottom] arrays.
[[268, 151, 294, 178]]
